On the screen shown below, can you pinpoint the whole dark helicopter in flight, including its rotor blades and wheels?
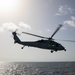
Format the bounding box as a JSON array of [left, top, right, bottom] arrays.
[[12, 24, 75, 53]]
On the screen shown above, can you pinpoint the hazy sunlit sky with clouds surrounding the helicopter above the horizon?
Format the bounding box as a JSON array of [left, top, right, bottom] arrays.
[[0, 0, 75, 62]]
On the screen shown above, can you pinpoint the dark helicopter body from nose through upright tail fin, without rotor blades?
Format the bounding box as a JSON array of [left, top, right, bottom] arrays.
[[12, 32, 65, 51]]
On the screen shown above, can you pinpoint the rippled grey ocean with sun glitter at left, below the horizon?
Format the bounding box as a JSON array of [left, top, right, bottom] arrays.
[[0, 62, 75, 75]]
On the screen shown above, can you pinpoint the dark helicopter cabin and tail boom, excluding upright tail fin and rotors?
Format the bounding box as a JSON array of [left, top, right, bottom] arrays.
[[20, 40, 65, 50]]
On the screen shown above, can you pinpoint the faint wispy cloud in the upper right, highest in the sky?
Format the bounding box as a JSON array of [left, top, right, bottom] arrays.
[[55, 5, 73, 16]]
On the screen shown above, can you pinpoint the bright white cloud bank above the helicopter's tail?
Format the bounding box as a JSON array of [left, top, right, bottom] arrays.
[[0, 22, 31, 32]]
